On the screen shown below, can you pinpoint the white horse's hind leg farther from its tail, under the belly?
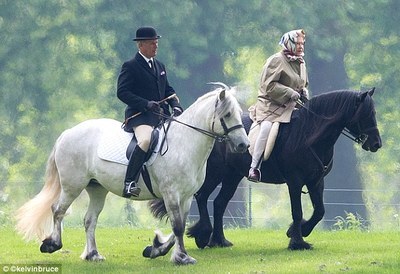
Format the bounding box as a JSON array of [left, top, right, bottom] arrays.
[[81, 180, 108, 261]]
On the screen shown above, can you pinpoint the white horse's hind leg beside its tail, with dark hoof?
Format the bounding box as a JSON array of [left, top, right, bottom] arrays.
[[40, 188, 82, 253]]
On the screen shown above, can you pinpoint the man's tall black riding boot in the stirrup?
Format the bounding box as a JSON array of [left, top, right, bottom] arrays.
[[122, 146, 147, 198]]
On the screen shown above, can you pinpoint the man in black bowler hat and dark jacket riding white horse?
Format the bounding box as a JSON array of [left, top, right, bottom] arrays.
[[117, 27, 183, 198]]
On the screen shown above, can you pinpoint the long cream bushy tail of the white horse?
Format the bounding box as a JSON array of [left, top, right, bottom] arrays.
[[16, 146, 61, 241]]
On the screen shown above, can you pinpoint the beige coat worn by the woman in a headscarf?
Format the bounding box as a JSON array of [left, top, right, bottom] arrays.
[[249, 52, 308, 123]]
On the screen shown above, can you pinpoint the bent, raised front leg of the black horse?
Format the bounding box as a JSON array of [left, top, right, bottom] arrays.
[[301, 179, 325, 237]]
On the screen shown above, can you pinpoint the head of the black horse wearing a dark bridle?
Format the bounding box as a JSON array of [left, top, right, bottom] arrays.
[[346, 88, 382, 152]]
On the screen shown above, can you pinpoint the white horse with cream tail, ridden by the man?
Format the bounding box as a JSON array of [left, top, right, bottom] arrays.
[[17, 86, 249, 264]]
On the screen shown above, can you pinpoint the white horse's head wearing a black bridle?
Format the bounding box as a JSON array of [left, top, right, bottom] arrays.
[[211, 82, 250, 153]]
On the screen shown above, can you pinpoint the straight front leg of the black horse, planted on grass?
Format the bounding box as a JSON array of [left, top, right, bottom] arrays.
[[286, 182, 311, 250]]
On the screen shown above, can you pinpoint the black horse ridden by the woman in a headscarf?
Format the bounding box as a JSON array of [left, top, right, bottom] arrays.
[[187, 89, 382, 250]]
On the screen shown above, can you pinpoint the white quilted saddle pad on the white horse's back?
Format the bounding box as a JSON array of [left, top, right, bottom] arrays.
[[97, 127, 164, 166]]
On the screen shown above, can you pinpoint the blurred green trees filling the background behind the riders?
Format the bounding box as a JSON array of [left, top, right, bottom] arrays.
[[0, 0, 400, 229]]
